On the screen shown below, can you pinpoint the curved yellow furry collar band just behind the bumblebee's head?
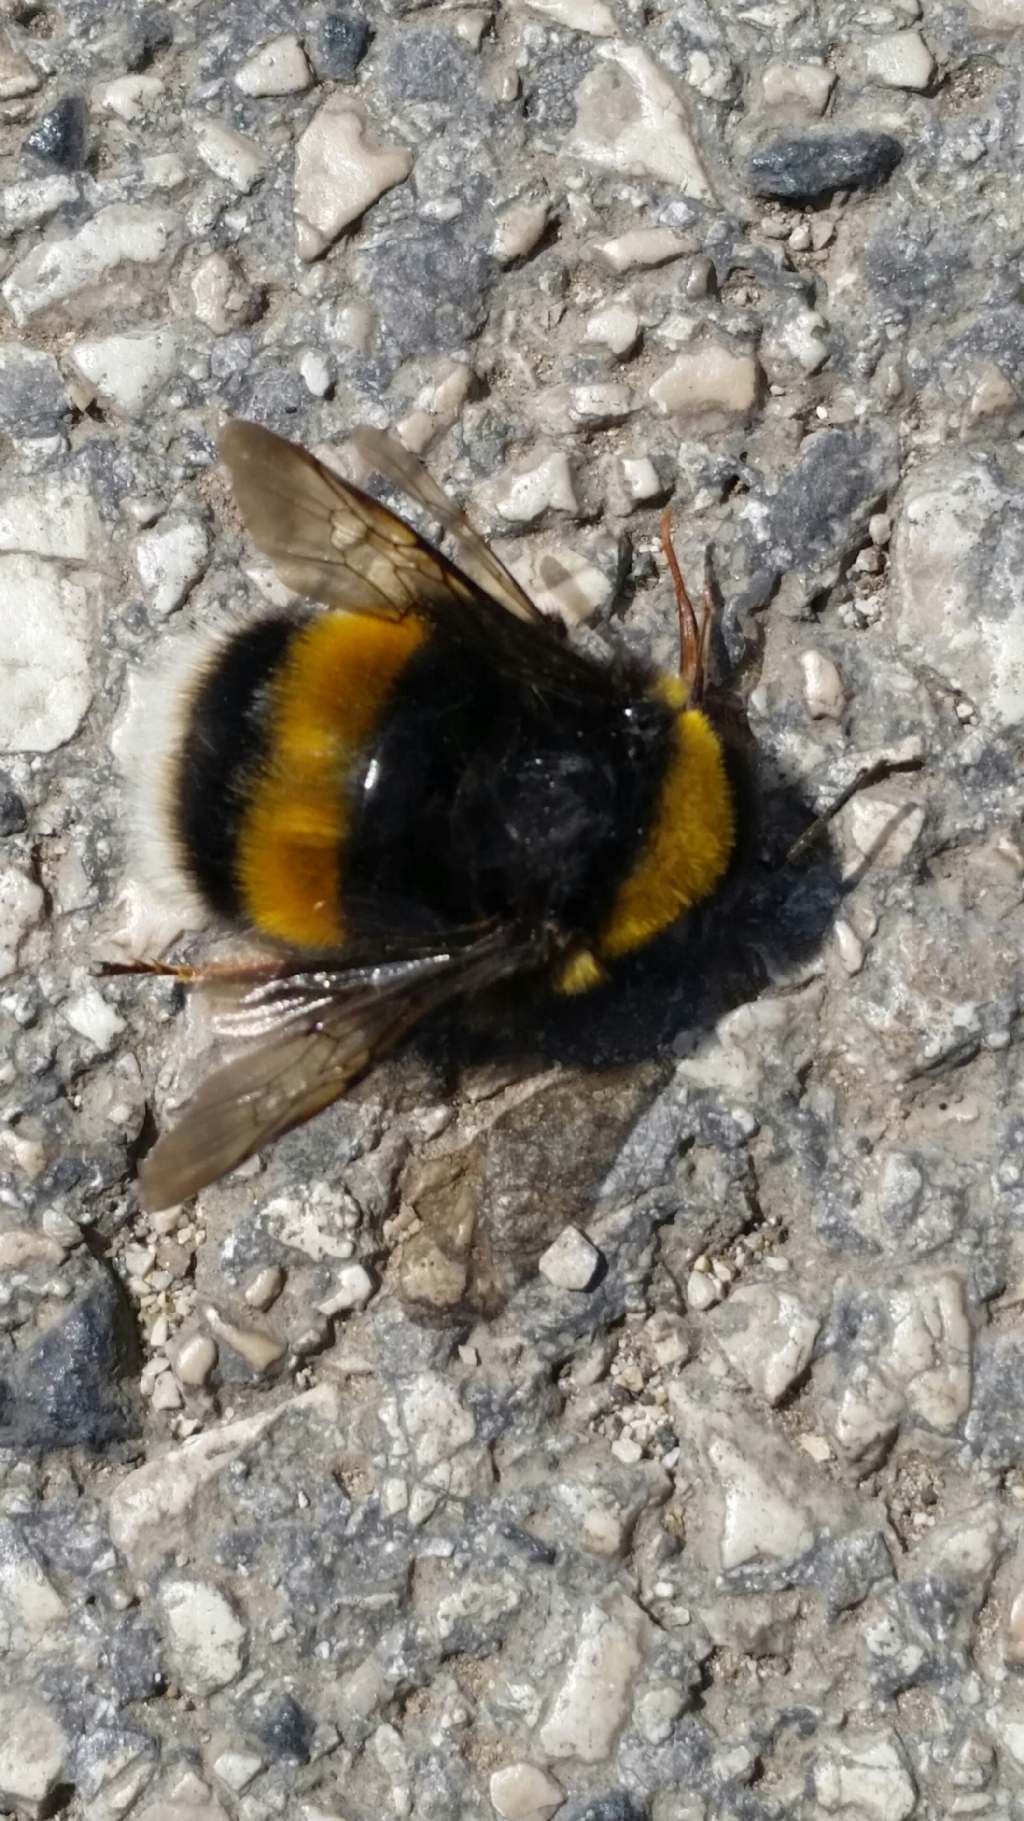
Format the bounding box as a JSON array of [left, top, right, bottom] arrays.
[[556, 679, 736, 992]]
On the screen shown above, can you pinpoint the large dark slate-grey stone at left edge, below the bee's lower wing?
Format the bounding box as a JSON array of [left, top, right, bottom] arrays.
[[0, 1275, 138, 1450]]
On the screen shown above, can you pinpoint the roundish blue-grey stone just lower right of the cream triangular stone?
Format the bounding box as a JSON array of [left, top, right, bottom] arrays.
[[364, 222, 496, 355]]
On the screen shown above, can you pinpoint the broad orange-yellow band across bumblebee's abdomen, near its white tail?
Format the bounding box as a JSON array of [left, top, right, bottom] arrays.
[[237, 614, 426, 949]]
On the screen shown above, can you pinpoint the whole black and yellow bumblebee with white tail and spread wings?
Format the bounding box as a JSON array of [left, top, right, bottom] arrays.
[[117, 422, 738, 1207]]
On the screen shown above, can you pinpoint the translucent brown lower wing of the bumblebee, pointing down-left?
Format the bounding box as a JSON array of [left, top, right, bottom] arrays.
[[138, 929, 545, 1211]]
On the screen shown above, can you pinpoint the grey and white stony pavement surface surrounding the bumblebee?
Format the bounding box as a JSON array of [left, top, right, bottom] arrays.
[[0, 0, 1024, 1821]]
